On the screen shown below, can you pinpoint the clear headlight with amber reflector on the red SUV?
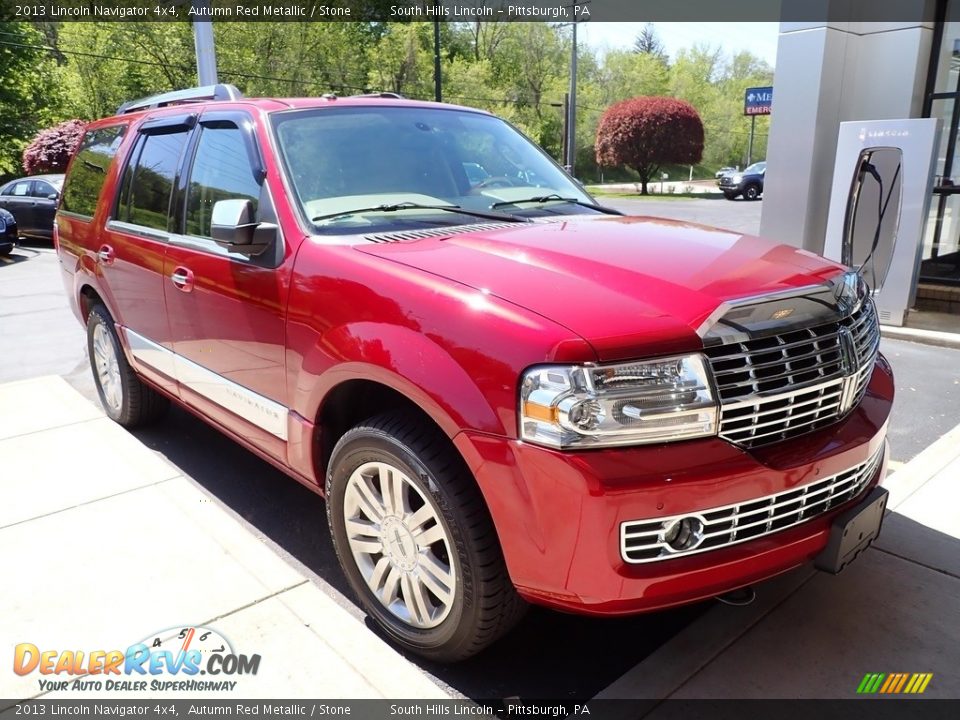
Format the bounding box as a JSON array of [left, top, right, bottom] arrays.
[[520, 355, 717, 448]]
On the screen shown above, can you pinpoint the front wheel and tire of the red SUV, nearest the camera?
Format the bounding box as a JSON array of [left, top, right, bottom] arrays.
[[326, 412, 526, 661]]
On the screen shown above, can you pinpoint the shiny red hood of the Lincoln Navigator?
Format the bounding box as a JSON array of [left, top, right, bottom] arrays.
[[356, 216, 843, 360]]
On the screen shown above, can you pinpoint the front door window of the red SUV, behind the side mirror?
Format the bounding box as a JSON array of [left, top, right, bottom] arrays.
[[186, 125, 260, 237]]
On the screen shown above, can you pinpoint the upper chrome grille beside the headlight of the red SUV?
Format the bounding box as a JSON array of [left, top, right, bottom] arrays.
[[704, 300, 880, 447]]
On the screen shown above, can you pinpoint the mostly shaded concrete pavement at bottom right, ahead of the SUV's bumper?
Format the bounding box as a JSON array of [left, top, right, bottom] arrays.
[[597, 426, 960, 704]]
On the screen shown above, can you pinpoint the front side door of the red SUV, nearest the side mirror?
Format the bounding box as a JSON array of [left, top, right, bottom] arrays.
[[163, 110, 292, 460]]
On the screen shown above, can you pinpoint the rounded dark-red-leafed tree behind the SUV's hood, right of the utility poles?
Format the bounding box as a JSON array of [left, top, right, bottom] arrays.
[[596, 97, 703, 195]]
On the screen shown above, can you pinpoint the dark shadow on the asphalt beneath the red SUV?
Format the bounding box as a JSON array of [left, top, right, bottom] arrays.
[[134, 408, 709, 700]]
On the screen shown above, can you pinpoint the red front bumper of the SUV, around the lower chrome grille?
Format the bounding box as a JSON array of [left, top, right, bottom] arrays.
[[455, 359, 894, 615]]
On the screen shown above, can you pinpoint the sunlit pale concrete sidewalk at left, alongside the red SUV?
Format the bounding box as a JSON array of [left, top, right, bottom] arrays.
[[0, 376, 448, 699]]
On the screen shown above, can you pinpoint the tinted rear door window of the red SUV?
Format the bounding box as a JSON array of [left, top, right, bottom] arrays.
[[117, 132, 187, 230]]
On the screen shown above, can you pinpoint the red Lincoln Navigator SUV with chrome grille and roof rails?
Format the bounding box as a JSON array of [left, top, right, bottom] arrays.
[[57, 85, 893, 660]]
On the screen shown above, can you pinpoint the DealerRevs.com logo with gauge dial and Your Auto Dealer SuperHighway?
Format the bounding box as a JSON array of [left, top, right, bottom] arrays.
[[13, 627, 260, 692]]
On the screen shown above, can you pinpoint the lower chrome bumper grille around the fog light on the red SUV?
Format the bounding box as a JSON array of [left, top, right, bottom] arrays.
[[620, 445, 883, 563]]
